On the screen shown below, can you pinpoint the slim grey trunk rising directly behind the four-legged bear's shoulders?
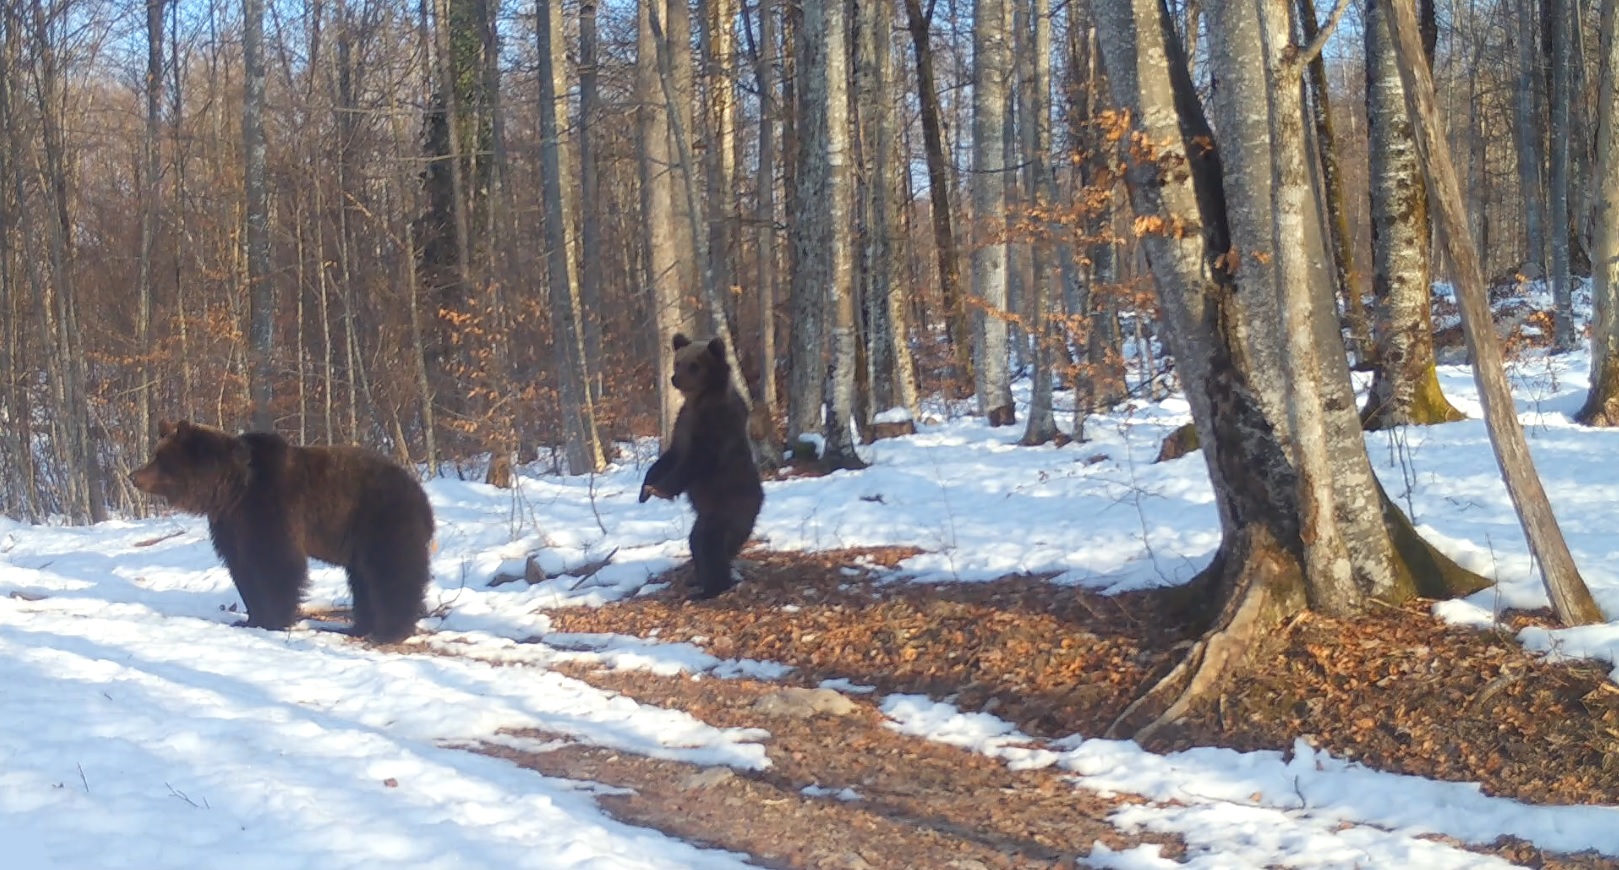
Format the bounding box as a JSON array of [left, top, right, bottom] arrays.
[[241, 0, 275, 433]]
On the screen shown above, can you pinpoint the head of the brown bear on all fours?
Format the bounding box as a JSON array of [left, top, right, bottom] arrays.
[[130, 420, 251, 514]]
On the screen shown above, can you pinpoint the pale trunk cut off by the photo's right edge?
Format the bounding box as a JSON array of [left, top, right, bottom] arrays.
[[1575, 0, 1619, 426]]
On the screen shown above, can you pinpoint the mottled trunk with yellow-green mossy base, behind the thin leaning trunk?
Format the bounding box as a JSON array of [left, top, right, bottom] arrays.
[[1362, 2, 1467, 429]]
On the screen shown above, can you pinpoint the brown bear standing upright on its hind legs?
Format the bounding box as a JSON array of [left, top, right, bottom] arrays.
[[641, 334, 764, 599]]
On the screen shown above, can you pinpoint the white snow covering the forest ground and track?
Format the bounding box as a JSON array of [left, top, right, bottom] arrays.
[[0, 332, 1619, 870]]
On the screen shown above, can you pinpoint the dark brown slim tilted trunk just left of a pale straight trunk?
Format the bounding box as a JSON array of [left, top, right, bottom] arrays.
[[905, 0, 975, 395]]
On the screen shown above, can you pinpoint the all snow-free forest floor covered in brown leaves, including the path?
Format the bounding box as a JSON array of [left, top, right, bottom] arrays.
[[489, 549, 1619, 868]]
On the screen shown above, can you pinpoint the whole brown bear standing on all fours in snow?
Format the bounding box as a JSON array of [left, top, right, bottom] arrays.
[[130, 421, 434, 643]]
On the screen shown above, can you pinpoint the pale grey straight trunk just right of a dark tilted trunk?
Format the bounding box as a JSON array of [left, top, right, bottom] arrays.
[[970, 0, 1017, 426]]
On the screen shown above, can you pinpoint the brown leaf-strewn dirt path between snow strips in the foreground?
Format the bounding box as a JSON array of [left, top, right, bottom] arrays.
[[472, 666, 1183, 870]]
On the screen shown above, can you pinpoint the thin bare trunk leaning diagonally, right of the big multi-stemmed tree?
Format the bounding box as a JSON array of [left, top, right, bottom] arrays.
[[1378, 0, 1603, 625]]
